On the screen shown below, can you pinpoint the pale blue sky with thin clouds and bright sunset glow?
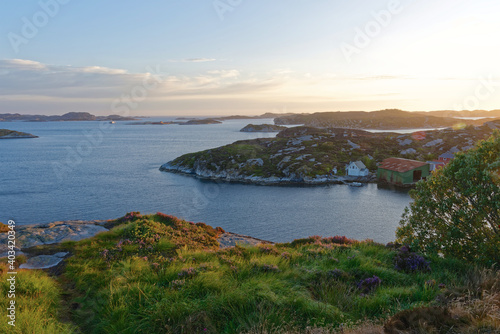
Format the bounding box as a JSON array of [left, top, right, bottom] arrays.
[[0, 0, 500, 116]]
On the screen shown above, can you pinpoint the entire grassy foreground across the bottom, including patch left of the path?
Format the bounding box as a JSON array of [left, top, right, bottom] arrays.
[[0, 213, 500, 333]]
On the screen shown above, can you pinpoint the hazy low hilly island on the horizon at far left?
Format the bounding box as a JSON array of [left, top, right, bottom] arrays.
[[0, 112, 138, 122]]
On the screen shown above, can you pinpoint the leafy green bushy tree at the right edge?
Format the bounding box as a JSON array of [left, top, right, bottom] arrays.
[[396, 131, 500, 265]]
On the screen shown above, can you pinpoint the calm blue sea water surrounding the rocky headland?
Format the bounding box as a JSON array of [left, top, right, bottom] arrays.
[[0, 118, 410, 242]]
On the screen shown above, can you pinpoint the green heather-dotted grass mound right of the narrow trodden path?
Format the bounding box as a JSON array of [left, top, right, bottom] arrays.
[[61, 215, 484, 333]]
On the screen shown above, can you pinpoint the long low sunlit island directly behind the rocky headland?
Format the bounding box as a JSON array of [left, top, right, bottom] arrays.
[[274, 109, 492, 130]]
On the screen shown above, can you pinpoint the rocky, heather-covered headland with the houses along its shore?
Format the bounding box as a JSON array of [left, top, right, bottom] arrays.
[[160, 120, 500, 185]]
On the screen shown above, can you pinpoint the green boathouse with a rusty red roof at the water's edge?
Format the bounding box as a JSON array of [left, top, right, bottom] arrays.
[[377, 158, 430, 186]]
